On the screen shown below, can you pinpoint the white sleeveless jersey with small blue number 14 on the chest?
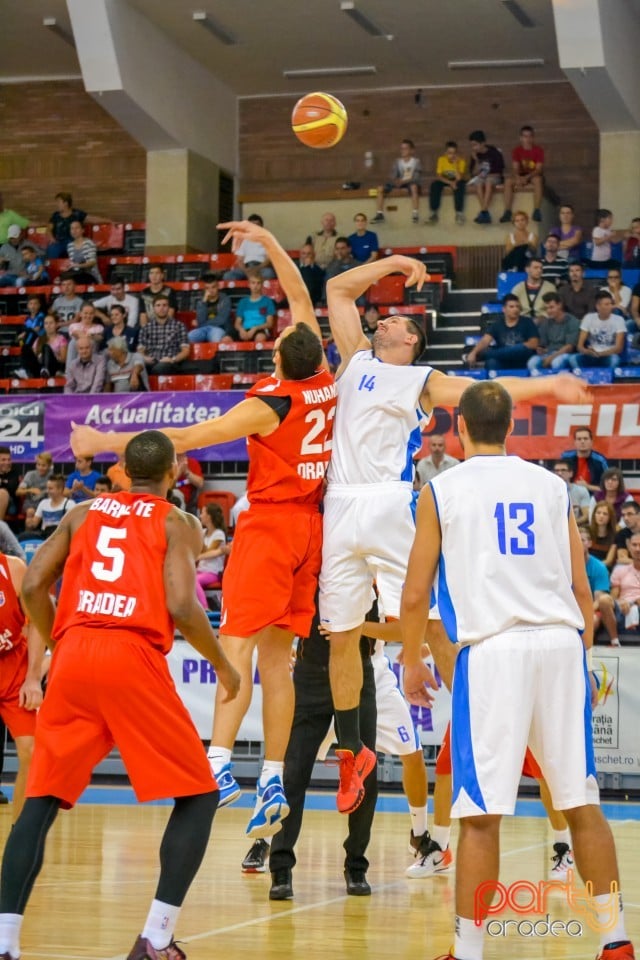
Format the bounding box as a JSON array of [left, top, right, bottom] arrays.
[[328, 350, 432, 485]]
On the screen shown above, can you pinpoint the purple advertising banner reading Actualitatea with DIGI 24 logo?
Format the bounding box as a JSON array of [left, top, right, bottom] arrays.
[[0, 390, 247, 463]]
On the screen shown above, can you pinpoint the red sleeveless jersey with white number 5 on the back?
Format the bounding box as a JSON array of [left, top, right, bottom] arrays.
[[53, 492, 173, 653]]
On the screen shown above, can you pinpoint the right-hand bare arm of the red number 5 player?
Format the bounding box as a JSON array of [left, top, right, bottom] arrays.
[[164, 509, 240, 702]]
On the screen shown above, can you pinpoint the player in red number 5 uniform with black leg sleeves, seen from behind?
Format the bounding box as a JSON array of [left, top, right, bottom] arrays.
[[0, 431, 240, 960]]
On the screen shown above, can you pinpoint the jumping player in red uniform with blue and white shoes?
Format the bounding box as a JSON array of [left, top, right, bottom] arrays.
[[71, 221, 336, 838]]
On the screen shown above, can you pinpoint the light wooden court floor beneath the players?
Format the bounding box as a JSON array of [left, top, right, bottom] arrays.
[[0, 804, 640, 960]]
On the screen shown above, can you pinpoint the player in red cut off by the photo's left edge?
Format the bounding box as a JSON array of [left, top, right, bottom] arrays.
[[0, 553, 44, 820]]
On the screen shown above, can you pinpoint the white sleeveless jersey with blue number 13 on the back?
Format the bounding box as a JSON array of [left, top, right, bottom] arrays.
[[430, 456, 584, 643]]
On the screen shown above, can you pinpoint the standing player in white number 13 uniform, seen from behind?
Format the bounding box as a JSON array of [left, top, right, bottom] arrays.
[[401, 381, 634, 960]]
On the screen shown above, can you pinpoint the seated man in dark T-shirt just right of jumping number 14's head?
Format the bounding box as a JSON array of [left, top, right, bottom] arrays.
[[466, 293, 540, 370]]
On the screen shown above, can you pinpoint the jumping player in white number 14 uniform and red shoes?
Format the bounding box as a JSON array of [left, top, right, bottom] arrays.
[[320, 255, 587, 813]]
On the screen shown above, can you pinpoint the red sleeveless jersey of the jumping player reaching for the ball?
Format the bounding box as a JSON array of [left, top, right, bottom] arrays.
[[247, 370, 336, 504]]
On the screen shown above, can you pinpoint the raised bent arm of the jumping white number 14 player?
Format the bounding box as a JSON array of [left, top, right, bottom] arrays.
[[327, 254, 428, 373]]
